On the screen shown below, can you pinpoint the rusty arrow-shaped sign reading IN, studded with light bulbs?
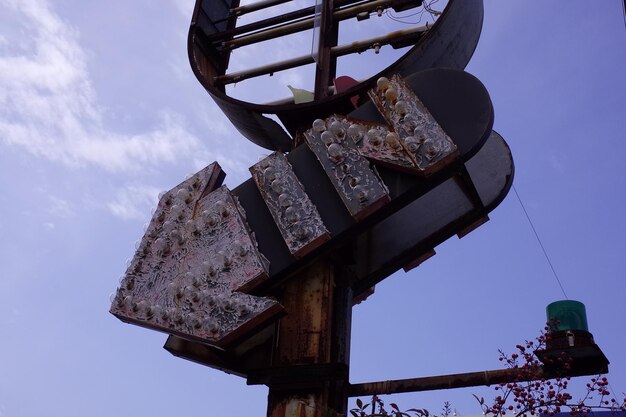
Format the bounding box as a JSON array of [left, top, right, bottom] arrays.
[[111, 70, 512, 364]]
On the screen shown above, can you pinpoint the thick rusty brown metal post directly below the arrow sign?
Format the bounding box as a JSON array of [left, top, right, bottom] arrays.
[[267, 259, 352, 417]]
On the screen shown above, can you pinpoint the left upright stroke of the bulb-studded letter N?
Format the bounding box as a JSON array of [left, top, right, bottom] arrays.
[[304, 115, 390, 220]]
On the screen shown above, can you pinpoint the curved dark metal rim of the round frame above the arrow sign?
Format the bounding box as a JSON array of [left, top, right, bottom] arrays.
[[188, 0, 483, 151]]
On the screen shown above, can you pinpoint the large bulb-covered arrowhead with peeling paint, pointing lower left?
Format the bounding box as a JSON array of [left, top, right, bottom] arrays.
[[111, 164, 281, 346]]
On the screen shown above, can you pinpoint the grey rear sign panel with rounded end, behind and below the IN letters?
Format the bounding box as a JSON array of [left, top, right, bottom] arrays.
[[355, 132, 514, 294]]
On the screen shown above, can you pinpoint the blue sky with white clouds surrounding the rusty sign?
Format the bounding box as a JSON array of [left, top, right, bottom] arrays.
[[0, 0, 626, 417]]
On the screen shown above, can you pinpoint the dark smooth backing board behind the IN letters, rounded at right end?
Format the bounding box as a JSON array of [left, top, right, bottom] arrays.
[[225, 69, 493, 285]]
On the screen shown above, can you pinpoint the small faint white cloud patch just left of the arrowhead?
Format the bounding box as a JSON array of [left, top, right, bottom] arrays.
[[107, 185, 160, 220]]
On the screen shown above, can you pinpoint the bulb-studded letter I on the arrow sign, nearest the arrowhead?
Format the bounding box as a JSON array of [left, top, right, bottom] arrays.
[[250, 152, 330, 258]]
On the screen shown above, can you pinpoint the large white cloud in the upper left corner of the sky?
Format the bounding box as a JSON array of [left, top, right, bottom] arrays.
[[0, 0, 202, 172]]
